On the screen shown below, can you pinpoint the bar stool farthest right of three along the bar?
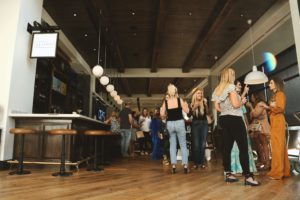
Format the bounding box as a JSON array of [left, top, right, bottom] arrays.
[[84, 130, 112, 171]]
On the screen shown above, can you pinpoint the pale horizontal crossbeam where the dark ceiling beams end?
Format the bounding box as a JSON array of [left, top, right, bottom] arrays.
[[107, 68, 210, 78]]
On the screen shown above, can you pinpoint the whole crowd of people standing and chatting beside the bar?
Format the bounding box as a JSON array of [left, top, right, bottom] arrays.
[[106, 68, 290, 186]]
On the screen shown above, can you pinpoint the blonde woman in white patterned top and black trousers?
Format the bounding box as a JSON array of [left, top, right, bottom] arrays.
[[212, 68, 260, 186]]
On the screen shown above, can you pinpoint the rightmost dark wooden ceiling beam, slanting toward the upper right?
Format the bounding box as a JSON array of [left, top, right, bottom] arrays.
[[182, 0, 237, 72]]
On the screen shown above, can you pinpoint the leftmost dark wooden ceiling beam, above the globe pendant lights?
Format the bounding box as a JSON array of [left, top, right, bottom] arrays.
[[83, 0, 125, 72]]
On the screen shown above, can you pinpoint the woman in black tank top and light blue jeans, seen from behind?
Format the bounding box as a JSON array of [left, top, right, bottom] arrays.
[[161, 84, 189, 174]]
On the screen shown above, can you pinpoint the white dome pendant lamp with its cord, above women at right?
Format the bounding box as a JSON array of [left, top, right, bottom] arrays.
[[244, 19, 268, 85]]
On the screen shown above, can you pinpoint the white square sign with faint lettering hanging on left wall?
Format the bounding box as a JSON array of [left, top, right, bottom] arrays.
[[30, 33, 58, 58]]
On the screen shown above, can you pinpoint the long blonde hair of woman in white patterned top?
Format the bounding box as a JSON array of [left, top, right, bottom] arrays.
[[214, 67, 235, 96]]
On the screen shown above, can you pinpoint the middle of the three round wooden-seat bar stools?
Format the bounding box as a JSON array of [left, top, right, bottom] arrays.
[[48, 129, 77, 176]]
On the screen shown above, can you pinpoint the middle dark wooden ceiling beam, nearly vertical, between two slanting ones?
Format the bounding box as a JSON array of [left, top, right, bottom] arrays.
[[151, 0, 166, 72]]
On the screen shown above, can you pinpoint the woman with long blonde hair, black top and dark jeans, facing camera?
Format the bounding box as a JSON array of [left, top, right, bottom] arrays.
[[191, 88, 209, 169]]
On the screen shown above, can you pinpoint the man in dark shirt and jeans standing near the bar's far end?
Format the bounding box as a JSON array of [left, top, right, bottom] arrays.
[[120, 102, 132, 157]]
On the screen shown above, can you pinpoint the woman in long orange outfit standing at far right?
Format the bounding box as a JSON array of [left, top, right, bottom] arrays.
[[266, 77, 290, 180]]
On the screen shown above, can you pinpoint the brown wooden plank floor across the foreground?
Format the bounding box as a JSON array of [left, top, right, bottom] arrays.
[[0, 157, 300, 200]]
